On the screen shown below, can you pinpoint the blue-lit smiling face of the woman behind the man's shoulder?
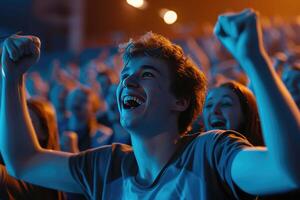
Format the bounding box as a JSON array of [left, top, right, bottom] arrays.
[[203, 87, 244, 131]]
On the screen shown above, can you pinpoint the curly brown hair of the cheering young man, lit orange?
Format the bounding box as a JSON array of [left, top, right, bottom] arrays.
[[120, 32, 207, 135]]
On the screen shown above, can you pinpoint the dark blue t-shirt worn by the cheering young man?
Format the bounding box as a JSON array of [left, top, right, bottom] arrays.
[[69, 131, 254, 200]]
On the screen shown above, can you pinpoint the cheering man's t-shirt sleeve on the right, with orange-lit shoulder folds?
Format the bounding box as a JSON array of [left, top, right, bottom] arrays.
[[206, 131, 255, 200]]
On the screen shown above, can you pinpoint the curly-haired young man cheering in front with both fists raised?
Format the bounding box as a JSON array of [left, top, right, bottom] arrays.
[[0, 10, 300, 199]]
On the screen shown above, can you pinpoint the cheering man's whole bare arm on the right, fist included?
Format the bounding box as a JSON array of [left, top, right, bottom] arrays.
[[215, 10, 300, 195]]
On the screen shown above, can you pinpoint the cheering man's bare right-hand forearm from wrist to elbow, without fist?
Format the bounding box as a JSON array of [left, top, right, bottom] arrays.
[[241, 54, 300, 178]]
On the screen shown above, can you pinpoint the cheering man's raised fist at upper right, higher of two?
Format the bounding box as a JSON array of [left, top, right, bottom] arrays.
[[215, 9, 265, 63]]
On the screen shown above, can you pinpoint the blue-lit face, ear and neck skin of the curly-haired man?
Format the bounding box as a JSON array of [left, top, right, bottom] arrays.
[[117, 56, 188, 183]]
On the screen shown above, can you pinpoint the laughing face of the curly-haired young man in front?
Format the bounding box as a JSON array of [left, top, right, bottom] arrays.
[[117, 57, 178, 134]]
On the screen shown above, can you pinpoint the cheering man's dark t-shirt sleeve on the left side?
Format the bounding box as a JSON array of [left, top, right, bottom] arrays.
[[69, 146, 111, 199]]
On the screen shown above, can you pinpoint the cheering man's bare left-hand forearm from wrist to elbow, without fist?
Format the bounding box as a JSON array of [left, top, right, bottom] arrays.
[[0, 78, 39, 175]]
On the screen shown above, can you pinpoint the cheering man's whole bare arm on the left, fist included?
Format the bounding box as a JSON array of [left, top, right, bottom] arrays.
[[0, 36, 80, 192]]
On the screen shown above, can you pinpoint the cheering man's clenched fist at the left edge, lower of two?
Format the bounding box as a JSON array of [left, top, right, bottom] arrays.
[[1, 35, 41, 81]]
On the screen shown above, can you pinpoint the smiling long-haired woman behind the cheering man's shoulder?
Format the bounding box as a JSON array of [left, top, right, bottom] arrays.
[[203, 81, 264, 146]]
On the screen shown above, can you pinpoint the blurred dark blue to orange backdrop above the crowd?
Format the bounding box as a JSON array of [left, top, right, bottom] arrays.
[[0, 0, 300, 51]]
